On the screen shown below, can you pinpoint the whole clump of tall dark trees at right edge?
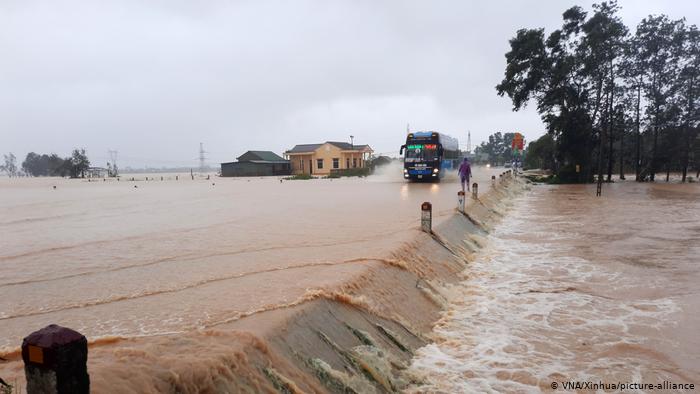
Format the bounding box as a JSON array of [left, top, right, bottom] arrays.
[[496, 1, 700, 182]]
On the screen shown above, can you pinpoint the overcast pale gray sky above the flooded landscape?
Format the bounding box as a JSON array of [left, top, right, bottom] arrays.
[[0, 0, 700, 167]]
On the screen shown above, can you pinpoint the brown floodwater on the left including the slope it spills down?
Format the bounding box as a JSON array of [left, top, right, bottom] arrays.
[[0, 169, 509, 393]]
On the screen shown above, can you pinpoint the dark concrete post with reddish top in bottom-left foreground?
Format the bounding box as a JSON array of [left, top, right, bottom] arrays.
[[22, 324, 90, 394]]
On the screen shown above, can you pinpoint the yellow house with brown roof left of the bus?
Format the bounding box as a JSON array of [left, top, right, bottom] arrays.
[[284, 141, 372, 175]]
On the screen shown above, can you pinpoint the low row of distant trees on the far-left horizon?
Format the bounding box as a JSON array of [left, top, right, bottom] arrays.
[[0, 149, 90, 178]]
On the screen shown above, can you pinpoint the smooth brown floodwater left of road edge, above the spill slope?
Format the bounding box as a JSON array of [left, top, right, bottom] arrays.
[[0, 166, 498, 351]]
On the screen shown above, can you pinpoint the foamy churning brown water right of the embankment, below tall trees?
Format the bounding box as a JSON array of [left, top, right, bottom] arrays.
[[410, 182, 700, 393]]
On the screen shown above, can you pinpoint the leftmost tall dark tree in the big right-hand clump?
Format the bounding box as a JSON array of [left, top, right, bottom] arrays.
[[496, 2, 627, 182]]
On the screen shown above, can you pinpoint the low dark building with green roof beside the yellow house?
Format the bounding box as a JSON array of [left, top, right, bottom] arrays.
[[221, 150, 291, 176]]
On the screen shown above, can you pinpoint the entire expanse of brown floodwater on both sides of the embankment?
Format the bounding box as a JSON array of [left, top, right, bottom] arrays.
[[0, 168, 700, 393]]
